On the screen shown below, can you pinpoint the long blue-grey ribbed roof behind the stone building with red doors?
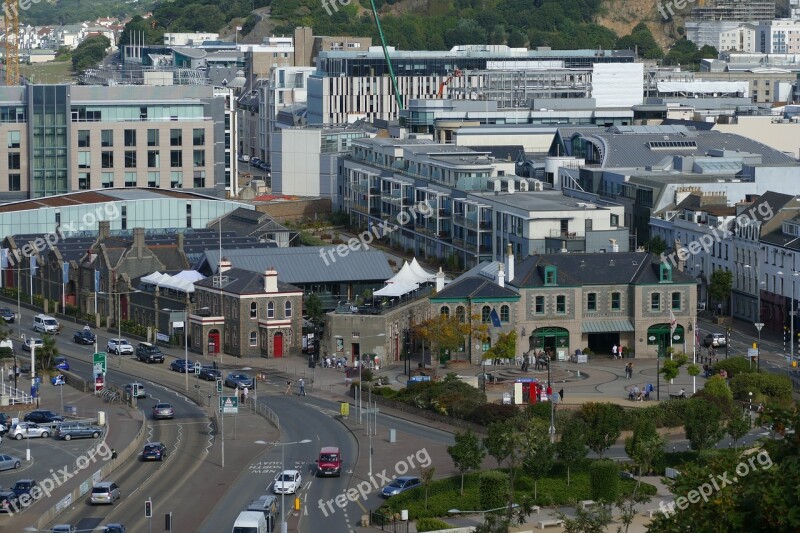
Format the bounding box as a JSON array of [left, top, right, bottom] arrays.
[[197, 246, 394, 284]]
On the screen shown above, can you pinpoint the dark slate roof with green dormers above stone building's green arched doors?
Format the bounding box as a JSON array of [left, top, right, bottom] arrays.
[[510, 252, 697, 288]]
